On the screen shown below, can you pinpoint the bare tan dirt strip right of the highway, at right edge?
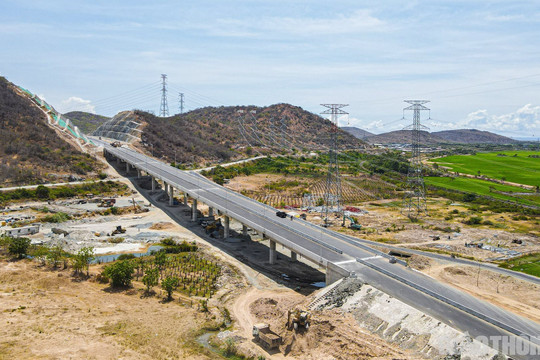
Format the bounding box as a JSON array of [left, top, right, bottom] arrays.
[[409, 255, 540, 322]]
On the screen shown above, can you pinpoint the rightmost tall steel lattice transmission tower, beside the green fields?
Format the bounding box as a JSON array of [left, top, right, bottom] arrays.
[[402, 100, 430, 218]]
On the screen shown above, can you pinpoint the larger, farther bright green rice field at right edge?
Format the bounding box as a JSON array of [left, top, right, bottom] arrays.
[[432, 151, 540, 190]]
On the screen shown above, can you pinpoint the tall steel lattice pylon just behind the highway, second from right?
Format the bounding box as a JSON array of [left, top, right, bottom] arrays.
[[321, 104, 349, 226]]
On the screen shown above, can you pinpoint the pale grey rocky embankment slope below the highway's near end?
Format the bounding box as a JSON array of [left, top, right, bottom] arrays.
[[314, 278, 497, 360]]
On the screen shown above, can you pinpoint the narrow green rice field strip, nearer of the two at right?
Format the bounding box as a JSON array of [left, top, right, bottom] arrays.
[[424, 177, 540, 206]]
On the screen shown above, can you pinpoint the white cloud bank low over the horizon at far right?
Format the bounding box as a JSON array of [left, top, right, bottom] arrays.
[[456, 104, 540, 134]]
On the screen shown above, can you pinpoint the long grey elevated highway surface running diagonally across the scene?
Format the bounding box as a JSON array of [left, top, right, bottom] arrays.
[[104, 144, 540, 359]]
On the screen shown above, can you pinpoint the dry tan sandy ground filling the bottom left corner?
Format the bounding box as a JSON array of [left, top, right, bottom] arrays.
[[0, 260, 219, 359]]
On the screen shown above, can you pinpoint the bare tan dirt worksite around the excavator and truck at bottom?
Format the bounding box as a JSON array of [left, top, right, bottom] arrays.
[[231, 289, 417, 360]]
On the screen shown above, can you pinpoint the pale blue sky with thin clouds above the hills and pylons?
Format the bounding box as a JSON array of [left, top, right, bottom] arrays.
[[0, 0, 540, 137]]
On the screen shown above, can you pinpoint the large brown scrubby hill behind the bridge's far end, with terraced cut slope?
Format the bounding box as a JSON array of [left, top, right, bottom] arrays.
[[94, 104, 365, 163]]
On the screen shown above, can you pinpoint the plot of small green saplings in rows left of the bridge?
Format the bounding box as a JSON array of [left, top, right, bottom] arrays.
[[135, 252, 221, 298]]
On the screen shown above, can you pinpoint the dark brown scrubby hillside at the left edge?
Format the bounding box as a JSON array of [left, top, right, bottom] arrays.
[[0, 77, 100, 186]]
